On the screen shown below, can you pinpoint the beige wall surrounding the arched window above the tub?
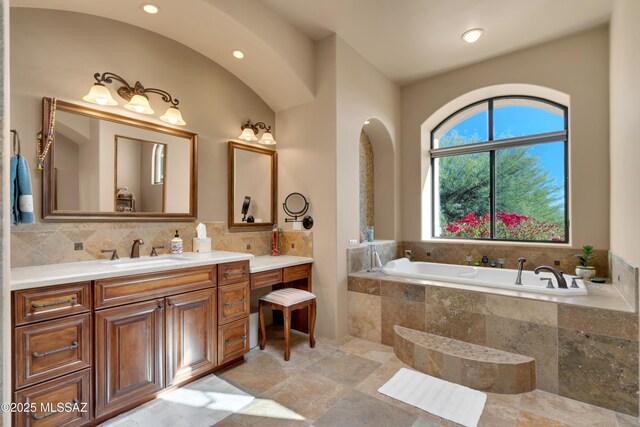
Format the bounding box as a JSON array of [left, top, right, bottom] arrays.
[[402, 27, 609, 249]]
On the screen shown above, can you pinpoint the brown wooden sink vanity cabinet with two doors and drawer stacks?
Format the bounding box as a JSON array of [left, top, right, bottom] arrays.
[[12, 261, 250, 426]]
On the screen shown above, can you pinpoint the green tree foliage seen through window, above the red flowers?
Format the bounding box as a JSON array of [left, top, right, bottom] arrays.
[[437, 131, 564, 231]]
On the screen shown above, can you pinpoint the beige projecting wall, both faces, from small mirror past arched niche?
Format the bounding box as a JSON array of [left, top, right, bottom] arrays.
[[276, 35, 400, 337]]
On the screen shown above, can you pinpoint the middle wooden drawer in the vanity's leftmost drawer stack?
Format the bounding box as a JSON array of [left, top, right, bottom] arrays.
[[14, 313, 91, 388]]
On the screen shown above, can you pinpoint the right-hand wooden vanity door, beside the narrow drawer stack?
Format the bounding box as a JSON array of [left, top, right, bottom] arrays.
[[166, 288, 216, 387]]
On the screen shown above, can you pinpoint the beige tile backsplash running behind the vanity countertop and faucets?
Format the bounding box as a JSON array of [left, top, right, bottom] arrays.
[[11, 221, 313, 267]]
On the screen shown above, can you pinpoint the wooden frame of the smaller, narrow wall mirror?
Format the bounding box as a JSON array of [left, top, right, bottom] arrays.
[[227, 141, 278, 231]]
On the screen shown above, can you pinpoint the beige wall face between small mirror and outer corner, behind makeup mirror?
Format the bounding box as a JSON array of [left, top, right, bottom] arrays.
[[276, 36, 338, 337]]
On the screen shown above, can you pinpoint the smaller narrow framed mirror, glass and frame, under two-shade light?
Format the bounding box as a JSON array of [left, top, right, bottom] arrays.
[[228, 141, 278, 230]]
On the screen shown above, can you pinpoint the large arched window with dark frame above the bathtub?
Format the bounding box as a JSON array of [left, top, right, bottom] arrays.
[[430, 96, 569, 243]]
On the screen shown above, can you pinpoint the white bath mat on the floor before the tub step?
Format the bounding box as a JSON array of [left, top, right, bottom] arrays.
[[378, 368, 487, 427]]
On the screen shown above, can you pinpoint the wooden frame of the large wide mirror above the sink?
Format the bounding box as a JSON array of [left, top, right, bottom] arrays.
[[42, 98, 198, 222]]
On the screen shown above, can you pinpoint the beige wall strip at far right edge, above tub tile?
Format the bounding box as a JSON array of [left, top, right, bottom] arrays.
[[610, 0, 640, 267]]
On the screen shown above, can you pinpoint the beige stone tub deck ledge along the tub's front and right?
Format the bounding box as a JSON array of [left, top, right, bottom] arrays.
[[349, 271, 634, 313]]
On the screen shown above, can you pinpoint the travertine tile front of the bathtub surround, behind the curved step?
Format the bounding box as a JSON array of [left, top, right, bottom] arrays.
[[348, 272, 640, 416]]
